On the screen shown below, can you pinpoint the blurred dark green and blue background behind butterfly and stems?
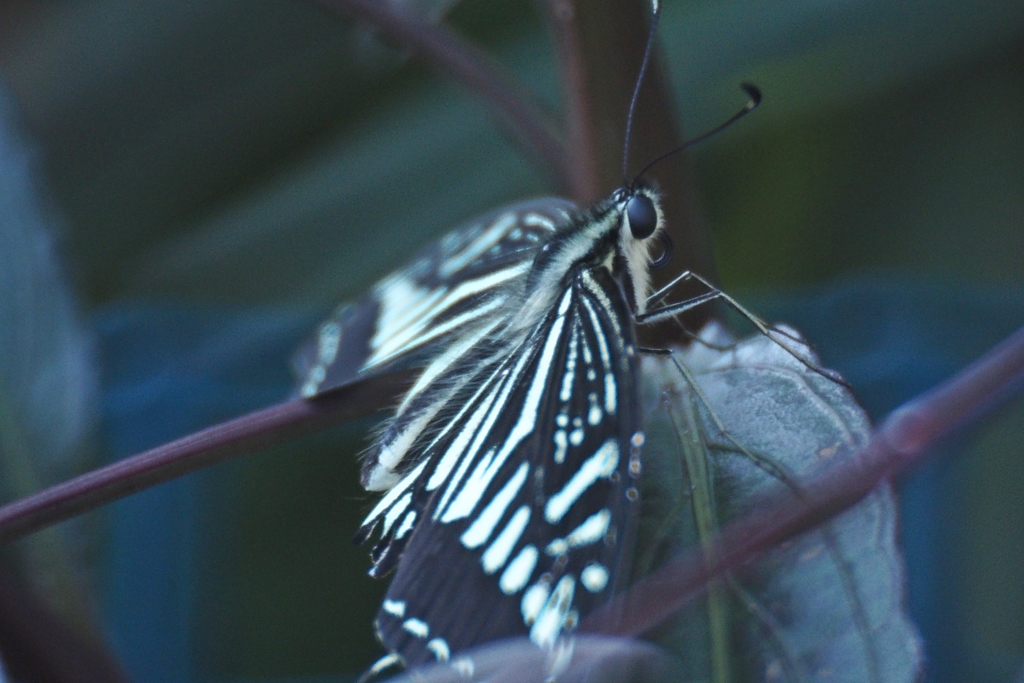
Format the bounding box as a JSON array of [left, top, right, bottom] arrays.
[[0, 0, 1024, 681]]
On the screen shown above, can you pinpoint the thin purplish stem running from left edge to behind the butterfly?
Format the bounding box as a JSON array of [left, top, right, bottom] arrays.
[[0, 375, 408, 545]]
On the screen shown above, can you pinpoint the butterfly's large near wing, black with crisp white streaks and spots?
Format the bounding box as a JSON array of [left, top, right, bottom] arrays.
[[360, 267, 643, 664]]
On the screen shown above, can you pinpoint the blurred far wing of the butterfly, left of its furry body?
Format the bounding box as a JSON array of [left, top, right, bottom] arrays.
[[292, 199, 575, 396]]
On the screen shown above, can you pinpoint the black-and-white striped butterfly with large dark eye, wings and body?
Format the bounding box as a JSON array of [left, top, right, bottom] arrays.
[[296, 185, 662, 664]]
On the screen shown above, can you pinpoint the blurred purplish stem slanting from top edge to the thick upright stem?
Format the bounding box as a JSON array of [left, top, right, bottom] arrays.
[[314, 0, 573, 191]]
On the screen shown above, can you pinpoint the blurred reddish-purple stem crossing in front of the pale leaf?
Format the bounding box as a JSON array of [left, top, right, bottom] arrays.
[[581, 328, 1024, 636]]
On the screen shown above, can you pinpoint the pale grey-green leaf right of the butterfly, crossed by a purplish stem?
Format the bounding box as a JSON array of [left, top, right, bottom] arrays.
[[637, 325, 922, 683]]
